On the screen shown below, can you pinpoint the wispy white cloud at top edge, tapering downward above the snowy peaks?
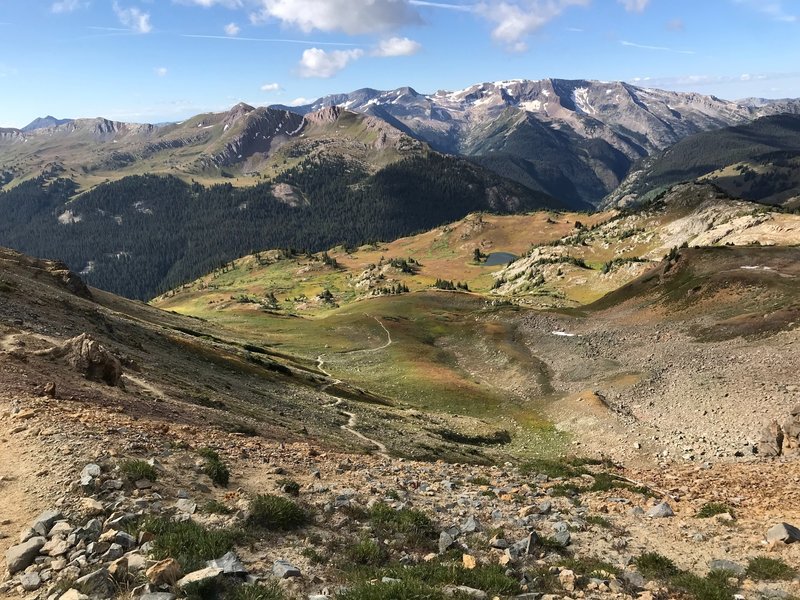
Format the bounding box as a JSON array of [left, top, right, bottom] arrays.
[[475, 0, 591, 52]]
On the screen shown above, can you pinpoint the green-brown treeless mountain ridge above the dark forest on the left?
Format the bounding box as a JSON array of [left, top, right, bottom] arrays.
[[0, 103, 438, 188]]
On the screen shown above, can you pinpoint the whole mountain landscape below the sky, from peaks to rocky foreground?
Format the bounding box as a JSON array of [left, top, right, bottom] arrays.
[[0, 79, 800, 600]]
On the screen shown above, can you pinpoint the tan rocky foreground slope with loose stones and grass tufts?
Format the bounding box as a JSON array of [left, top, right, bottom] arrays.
[[0, 366, 800, 600]]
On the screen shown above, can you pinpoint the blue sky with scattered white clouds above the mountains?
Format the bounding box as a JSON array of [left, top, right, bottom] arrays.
[[0, 0, 800, 127]]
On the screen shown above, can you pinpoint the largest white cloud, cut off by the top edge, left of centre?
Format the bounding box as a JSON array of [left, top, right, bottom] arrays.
[[250, 0, 421, 35]]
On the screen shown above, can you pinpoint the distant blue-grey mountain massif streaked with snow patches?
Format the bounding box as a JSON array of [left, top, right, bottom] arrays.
[[280, 79, 800, 203]]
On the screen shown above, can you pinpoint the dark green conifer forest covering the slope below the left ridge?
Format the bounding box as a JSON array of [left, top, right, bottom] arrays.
[[0, 154, 557, 300]]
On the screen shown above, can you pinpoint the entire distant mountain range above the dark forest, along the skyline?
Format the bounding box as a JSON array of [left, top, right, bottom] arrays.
[[6, 79, 800, 208]]
